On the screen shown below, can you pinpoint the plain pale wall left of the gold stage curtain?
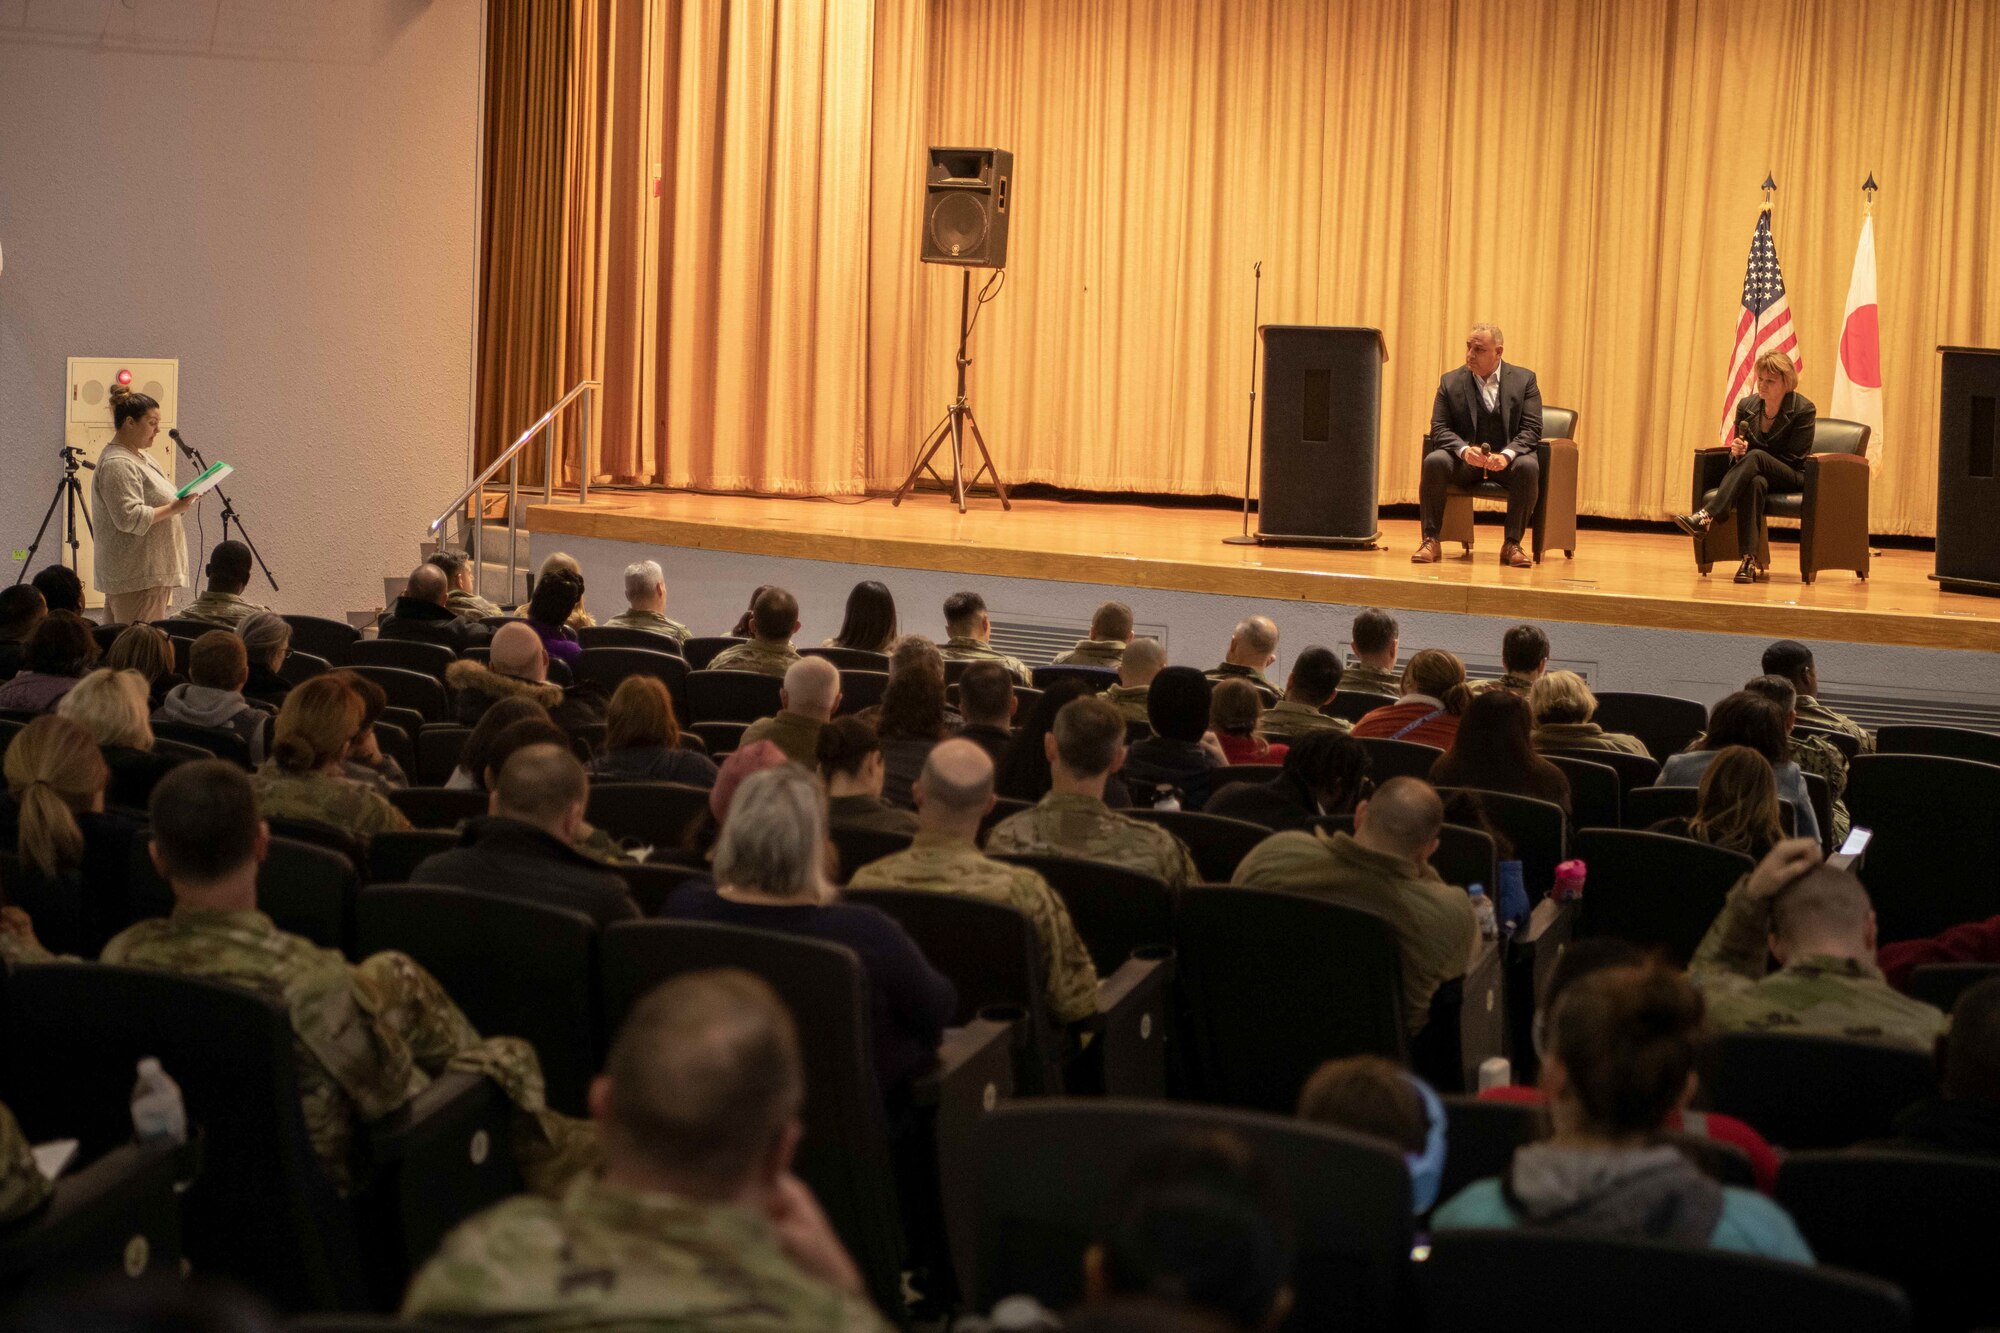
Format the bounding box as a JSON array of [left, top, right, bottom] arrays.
[[0, 0, 480, 616]]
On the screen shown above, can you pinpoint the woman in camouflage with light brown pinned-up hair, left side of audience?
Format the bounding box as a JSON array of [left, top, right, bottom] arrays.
[[250, 675, 410, 837]]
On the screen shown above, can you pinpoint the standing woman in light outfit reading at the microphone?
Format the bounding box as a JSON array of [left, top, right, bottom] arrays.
[[90, 384, 196, 624]]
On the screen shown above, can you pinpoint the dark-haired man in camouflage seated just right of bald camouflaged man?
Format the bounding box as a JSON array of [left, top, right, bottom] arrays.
[[986, 695, 1202, 889]]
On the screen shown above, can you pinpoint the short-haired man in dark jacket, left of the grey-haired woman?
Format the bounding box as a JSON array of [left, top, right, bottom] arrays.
[[410, 745, 640, 927]]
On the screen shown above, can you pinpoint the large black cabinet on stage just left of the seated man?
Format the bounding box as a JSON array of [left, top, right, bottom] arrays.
[[1256, 324, 1388, 546]]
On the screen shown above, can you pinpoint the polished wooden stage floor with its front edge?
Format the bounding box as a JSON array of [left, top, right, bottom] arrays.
[[526, 490, 2000, 650]]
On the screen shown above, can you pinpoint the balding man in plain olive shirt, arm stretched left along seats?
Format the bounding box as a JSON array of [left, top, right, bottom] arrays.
[[1232, 777, 1480, 1037]]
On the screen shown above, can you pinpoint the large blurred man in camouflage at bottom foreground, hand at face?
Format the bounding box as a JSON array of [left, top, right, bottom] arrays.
[[402, 971, 888, 1333]]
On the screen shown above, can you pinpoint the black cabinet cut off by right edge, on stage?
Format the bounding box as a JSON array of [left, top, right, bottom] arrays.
[[1932, 346, 2000, 596]]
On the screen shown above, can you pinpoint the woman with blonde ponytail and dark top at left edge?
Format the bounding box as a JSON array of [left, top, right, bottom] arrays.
[[0, 717, 144, 963]]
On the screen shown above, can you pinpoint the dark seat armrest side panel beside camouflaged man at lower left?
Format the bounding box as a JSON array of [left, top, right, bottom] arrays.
[[354, 1071, 522, 1293]]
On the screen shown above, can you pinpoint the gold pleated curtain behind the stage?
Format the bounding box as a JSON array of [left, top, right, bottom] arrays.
[[480, 0, 2000, 532]]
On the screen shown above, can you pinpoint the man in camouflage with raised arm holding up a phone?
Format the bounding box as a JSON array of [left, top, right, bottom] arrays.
[[1688, 839, 1946, 1055]]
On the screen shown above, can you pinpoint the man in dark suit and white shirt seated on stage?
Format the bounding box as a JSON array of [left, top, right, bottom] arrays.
[[1410, 324, 1542, 568]]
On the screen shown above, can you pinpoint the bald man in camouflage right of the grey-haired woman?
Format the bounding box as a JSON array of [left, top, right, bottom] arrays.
[[848, 741, 1098, 1023]]
